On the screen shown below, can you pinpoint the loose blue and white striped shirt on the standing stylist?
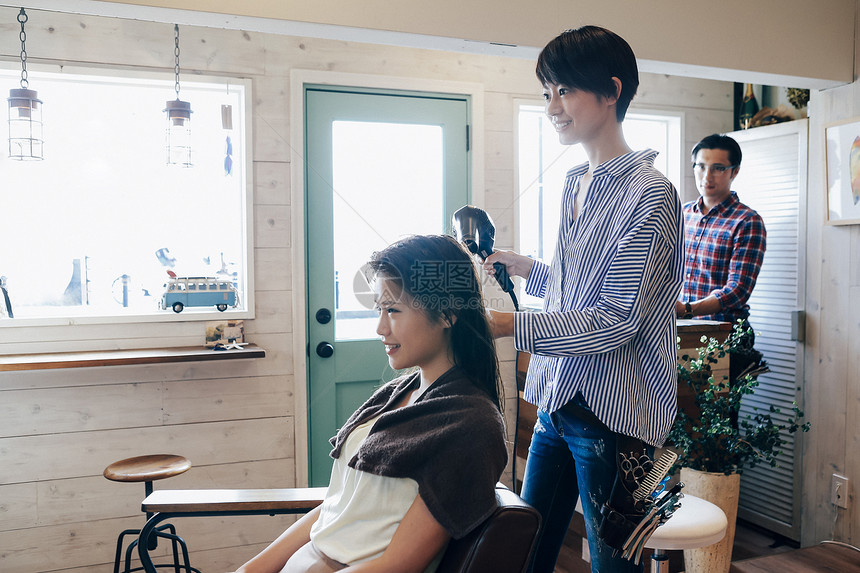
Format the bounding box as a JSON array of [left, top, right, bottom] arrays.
[[514, 150, 684, 446]]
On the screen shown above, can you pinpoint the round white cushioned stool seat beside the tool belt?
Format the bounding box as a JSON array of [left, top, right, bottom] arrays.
[[645, 495, 728, 550]]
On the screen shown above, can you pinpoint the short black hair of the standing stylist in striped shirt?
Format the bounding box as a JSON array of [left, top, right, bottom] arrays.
[[535, 26, 639, 122]]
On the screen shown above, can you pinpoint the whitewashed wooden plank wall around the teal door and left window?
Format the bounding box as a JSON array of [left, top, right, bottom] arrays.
[[0, 8, 731, 573]]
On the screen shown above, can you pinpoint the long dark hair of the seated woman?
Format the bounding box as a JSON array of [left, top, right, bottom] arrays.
[[368, 235, 503, 410]]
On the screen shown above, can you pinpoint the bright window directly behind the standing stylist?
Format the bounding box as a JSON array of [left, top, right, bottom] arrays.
[[517, 102, 682, 307]]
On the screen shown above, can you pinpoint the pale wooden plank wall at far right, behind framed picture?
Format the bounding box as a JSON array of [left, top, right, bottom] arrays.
[[801, 2, 860, 546]]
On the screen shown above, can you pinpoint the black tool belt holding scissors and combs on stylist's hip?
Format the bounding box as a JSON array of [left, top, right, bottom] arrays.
[[599, 447, 684, 565]]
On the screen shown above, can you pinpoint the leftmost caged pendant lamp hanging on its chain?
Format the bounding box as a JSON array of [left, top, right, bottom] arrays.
[[6, 8, 44, 161]]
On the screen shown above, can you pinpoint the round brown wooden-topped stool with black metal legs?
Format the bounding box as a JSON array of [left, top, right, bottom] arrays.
[[104, 454, 194, 573]]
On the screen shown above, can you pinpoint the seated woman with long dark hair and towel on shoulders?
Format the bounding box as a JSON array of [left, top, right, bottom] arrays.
[[232, 235, 507, 573]]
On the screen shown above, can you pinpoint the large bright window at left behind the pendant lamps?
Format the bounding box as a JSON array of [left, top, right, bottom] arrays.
[[0, 67, 253, 326]]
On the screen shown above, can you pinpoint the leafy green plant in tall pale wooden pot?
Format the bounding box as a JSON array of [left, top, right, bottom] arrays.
[[667, 321, 809, 572]]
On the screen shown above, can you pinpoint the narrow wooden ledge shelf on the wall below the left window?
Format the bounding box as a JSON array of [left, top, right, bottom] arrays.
[[0, 344, 266, 372]]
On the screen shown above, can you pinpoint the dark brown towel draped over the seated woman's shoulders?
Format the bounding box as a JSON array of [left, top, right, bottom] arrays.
[[331, 367, 508, 539]]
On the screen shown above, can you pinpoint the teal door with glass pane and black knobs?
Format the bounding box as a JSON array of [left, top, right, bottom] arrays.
[[304, 85, 469, 486]]
